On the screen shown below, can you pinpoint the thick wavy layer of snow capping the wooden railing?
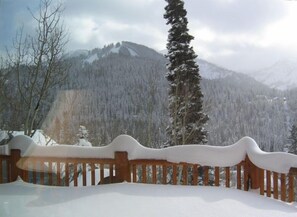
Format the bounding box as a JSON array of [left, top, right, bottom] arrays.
[[5, 135, 297, 173]]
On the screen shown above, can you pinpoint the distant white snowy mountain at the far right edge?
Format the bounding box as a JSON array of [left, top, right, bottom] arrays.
[[250, 59, 297, 90]]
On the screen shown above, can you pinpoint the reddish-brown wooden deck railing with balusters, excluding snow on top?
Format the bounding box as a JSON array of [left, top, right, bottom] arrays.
[[0, 136, 297, 202]]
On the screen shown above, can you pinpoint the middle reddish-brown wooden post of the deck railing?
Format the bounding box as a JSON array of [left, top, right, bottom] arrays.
[[115, 152, 131, 182]]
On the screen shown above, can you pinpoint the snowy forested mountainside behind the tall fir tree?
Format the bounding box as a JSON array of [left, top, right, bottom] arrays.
[[29, 42, 297, 151]]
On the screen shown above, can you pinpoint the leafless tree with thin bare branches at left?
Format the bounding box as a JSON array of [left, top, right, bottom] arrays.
[[7, 0, 68, 136]]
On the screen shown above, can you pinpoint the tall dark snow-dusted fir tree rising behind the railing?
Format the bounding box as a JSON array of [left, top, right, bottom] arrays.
[[164, 0, 208, 146]]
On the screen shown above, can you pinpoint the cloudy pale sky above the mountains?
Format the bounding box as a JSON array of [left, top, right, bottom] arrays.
[[0, 0, 297, 72]]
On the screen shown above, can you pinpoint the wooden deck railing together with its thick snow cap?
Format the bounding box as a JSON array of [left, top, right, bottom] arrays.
[[0, 135, 297, 202]]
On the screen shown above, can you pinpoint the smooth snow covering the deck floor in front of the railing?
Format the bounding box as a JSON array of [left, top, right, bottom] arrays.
[[0, 180, 297, 217]]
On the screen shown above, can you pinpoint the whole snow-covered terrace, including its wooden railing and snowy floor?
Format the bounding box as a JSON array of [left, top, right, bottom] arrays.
[[0, 135, 297, 216]]
